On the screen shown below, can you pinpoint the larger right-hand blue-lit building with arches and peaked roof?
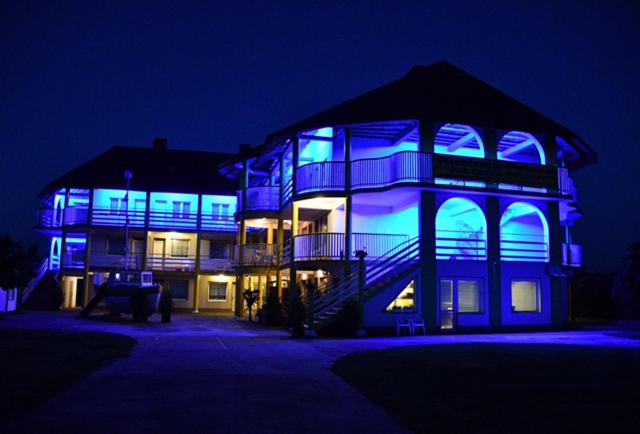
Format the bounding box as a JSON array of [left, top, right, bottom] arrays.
[[221, 62, 597, 332]]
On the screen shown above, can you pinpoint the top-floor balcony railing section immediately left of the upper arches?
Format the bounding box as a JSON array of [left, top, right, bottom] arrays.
[[351, 151, 433, 190]]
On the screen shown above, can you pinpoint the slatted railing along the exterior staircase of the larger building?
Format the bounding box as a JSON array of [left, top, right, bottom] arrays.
[[314, 237, 420, 322]]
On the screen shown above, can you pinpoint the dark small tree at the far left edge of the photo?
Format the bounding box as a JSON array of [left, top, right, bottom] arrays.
[[0, 235, 38, 308]]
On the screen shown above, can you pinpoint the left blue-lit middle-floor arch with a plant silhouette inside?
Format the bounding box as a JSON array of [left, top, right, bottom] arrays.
[[436, 197, 487, 261]]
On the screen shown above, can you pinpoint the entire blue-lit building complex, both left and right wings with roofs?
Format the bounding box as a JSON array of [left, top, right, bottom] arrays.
[[33, 62, 597, 332]]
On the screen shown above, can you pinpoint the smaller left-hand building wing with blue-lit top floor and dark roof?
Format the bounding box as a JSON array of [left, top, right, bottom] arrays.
[[37, 139, 237, 312]]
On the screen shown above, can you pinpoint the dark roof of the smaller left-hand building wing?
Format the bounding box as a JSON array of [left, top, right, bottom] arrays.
[[40, 146, 238, 197]]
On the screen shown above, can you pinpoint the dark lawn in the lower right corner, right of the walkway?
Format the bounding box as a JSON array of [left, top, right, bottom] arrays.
[[333, 344, 640, 434]]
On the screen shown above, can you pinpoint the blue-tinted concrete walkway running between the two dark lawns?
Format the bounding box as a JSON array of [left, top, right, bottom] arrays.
[[0, 313, 640, 434]]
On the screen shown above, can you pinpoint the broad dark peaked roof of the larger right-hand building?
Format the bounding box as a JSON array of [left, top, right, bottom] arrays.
[[266, 61, 597, 166]]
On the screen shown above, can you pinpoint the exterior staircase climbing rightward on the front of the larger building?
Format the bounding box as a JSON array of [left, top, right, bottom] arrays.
[[313, 238, 420, 330]]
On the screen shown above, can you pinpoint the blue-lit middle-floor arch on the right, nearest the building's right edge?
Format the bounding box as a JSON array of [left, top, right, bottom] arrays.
[[500, 202, 549, 262]]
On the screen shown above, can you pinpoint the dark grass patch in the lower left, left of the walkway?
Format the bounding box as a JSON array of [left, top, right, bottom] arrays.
[[0, 330, 135, 424]]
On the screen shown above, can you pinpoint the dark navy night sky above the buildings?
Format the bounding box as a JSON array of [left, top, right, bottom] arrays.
[[0, 0, 640, 270]]
